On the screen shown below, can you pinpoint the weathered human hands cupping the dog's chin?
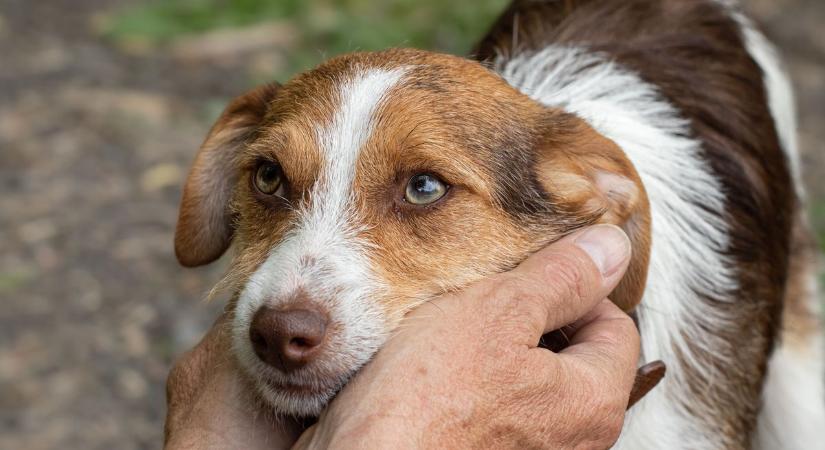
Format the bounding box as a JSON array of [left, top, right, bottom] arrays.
[[166, 225, 639, 449]]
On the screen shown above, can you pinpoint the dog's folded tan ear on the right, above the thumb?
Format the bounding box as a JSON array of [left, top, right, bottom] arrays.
[[537, 115, 651, 311]]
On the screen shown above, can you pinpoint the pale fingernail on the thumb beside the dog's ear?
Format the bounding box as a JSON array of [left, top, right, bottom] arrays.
[[573, 225, 630, 277]]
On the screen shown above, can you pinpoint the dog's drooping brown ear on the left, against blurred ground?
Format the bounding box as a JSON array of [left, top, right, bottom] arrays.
[[175, 83, 280, 267]]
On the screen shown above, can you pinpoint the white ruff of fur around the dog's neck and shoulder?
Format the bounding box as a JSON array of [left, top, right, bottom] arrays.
[[497, 46, 736, 450]]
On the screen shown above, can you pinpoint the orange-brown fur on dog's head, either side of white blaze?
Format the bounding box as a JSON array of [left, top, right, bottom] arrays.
[[178, 50, 649, 322]]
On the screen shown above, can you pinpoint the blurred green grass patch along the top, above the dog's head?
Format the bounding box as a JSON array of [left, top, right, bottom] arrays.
[[104, 0, 508, 79]]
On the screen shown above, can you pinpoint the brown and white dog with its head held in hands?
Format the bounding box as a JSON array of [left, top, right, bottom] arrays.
[[175, 0, 825, 449]]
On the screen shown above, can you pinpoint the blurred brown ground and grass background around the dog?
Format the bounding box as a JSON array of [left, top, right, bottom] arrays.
[[0, 0, 825, 449]]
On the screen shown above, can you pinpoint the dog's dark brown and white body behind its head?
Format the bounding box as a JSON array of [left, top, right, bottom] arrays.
[[479, 0, 825, 449]]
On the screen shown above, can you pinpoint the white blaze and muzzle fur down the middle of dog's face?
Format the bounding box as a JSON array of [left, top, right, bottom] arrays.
[[233, 69, 403, 415]]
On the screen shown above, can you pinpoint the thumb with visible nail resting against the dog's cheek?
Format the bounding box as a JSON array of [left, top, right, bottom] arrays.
[[483, 225, 630, 346]]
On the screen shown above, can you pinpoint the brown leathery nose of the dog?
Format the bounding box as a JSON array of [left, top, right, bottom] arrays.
[[249, 306, 327, 372]]
